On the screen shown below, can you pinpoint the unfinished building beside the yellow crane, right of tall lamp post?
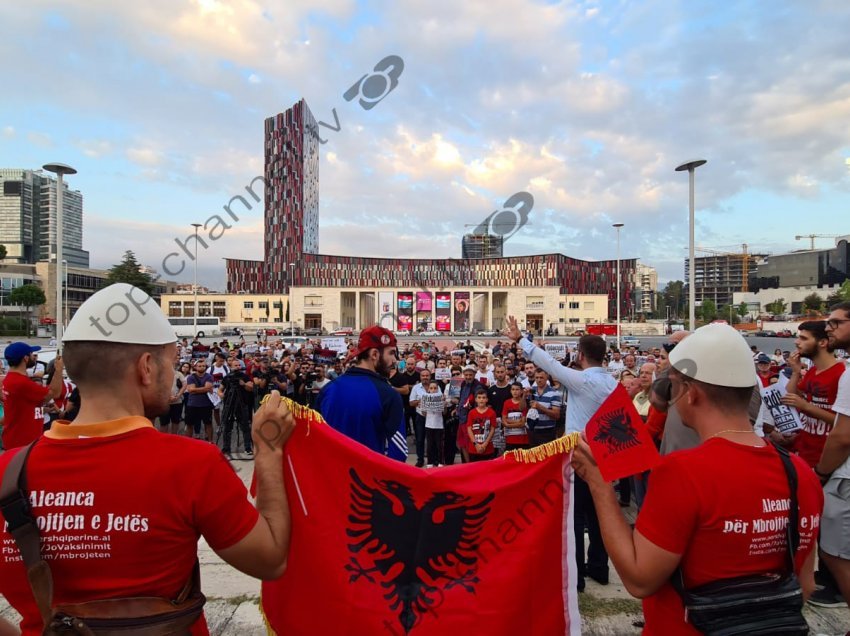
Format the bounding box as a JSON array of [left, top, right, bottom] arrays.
[[685, 245, 766, 307]]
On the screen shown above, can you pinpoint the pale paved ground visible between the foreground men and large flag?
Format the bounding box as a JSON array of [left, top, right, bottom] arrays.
[[0, 454, 850, 636]]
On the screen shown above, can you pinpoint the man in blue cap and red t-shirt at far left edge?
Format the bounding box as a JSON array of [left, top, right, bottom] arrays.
[[2, 342, 64, 450]]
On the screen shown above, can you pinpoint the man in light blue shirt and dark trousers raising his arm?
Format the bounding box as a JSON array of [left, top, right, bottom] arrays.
[[504, 316, 617, 592]]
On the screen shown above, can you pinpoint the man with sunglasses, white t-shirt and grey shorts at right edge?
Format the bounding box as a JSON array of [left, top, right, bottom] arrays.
[[815, 302, 850, 604]]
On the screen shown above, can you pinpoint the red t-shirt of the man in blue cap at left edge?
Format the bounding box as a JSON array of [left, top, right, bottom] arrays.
[[3, 371, 50, 450]]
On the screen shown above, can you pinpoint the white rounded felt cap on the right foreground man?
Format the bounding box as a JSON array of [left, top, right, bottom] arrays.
[[669, 323, 758, 388]]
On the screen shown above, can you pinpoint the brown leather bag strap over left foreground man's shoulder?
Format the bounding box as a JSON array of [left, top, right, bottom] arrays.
[[0, 440, 53, 625]]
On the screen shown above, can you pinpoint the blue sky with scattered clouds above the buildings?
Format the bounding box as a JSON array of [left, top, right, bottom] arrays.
[[0, 0, 850, 290]]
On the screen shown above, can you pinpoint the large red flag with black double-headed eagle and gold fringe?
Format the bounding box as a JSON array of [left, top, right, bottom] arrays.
[[253, 404, 581, 636]]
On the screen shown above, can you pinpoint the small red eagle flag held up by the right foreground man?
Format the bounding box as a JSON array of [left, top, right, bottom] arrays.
[[585, 384, 660, 481]]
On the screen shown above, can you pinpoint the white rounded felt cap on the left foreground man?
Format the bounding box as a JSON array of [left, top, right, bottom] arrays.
[[62, 283, 177, 345]]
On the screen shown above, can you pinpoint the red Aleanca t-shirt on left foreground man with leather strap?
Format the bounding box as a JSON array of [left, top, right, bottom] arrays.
[[0, 418, 258, 636]]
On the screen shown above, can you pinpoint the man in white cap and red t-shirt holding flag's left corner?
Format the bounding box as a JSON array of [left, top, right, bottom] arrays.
[[0, 283, 295, 634]]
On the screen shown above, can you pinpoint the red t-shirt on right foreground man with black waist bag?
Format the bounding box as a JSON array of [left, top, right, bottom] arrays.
[[635, 438, 823, 636]]
